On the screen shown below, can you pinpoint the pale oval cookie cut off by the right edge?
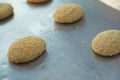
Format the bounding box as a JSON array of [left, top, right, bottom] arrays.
[[92, 30, 120, 56]]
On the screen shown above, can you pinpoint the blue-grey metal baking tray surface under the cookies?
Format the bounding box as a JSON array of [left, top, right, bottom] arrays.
[[0, 0, 120, 80]]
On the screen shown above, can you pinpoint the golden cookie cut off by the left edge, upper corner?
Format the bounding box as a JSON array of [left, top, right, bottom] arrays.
[[0, 3, 13, 20]]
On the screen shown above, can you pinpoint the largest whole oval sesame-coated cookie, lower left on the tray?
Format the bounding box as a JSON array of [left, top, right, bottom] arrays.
[[8, 36, 46, 63]]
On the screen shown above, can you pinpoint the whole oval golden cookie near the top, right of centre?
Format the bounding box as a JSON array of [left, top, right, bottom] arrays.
[[53, 4, 83, 23]]
